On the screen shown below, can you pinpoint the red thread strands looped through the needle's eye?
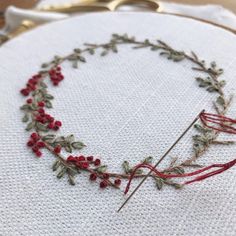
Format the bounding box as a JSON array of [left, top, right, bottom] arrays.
[[199, 112, 236, 134]]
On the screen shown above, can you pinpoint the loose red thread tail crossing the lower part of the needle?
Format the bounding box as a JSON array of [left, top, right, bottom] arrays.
[[124, 159, 236, 194]]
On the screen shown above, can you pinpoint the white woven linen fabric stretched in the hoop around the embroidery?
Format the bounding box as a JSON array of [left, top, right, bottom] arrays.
[[0, 13, 236, 236]]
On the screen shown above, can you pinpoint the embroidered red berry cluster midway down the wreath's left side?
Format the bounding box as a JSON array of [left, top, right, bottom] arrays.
[[26, 98, 62, 131]]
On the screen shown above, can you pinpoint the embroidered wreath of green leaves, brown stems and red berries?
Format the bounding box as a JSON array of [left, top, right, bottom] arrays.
[[21, 34, 233, 190]]
